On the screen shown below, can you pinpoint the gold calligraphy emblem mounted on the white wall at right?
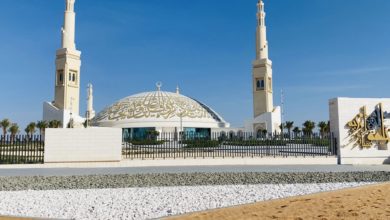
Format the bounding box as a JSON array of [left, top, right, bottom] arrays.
[[347, 103, 390, 148]]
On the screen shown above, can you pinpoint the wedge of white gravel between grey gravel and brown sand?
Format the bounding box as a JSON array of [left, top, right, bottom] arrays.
[[0, 183, 374, 219]]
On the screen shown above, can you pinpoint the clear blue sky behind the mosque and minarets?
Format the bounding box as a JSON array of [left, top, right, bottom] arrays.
[[0, 0, 390, 129]]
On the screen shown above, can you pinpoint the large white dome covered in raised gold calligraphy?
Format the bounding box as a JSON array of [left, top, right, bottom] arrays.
[[93, 91, 229, 128]]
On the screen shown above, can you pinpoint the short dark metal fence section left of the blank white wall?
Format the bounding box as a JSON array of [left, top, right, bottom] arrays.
[[0, 135, 45, 164]]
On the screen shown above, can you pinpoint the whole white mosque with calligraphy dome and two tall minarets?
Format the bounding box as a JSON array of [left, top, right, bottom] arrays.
[[43, 0, 281, 136]]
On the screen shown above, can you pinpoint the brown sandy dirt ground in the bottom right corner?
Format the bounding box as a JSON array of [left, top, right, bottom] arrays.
[[168, 183, 390, 220]]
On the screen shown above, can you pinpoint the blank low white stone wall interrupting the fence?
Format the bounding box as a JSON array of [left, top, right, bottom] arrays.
[[45, 128, 122, 163]]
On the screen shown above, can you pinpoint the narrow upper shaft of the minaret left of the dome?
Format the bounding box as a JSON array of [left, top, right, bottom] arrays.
[[62, 0, 76, 50]]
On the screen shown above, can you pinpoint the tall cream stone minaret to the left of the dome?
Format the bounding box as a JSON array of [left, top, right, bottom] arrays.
[[54, 0, 81, 115]]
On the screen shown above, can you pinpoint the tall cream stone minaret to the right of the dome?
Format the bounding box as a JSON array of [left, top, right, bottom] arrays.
[[252, 0, 274, 118]]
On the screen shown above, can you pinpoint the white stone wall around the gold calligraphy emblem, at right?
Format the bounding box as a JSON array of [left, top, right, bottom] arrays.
[[329, 98, 390, 164]]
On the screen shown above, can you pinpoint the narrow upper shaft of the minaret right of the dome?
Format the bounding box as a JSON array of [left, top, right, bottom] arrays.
[[256, 0, 268, 60]]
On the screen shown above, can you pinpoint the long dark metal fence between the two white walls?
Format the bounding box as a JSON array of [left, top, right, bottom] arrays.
[[122, 132, 337, 159]]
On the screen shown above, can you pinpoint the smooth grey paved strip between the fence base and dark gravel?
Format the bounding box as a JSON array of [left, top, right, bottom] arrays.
[[0, 165, 390, 176]]
